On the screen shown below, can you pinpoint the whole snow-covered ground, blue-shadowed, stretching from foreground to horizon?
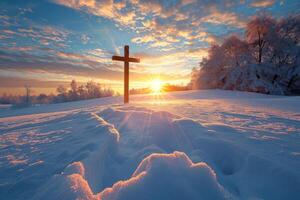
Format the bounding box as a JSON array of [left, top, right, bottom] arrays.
[[0, 90, 300, 200]]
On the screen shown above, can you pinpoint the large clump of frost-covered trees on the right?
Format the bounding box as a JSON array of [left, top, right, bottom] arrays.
[[189, 15, 300, 94]]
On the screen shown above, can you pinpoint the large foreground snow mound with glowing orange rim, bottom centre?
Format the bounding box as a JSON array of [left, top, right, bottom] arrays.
[[100, 152, 228, 200]]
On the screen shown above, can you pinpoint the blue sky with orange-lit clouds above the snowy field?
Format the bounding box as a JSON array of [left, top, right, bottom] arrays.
[[0, 0, 300, 94]]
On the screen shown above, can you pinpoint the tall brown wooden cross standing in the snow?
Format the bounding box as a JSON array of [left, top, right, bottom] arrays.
[[112, 45, 140, 103]]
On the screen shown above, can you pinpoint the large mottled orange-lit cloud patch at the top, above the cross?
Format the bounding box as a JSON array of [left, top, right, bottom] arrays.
[[55, 0, 245, 51]]
